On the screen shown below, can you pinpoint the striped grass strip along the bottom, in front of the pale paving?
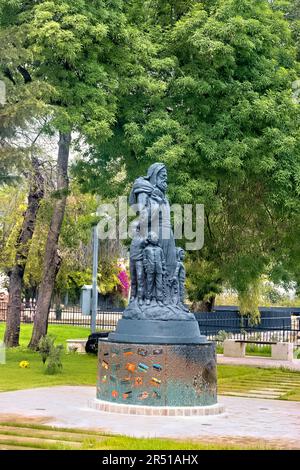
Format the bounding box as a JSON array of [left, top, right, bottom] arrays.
[[0, 419, 271, 450]]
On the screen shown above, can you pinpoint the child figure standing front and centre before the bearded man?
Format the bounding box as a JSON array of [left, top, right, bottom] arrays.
[[143, 232, 166, 306]]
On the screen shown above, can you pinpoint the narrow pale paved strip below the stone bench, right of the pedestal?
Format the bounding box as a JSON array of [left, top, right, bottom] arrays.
[[217, 354, 300, 372]]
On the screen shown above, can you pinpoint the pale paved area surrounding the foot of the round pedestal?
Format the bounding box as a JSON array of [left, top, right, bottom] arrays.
[[0, 386, 300, 449]]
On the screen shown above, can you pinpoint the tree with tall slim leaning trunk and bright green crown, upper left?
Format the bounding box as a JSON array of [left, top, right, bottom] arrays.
[[0, 0, 158, 348]]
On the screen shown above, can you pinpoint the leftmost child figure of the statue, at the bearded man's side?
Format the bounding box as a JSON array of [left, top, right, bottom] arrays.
[[130, 222, 146, 305]]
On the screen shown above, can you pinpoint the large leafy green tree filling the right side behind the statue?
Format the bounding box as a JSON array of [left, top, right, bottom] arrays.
[[74, 0, 300, 314]]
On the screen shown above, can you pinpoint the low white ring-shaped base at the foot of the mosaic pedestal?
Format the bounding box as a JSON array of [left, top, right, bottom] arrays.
[[89, 399, 225, 416]]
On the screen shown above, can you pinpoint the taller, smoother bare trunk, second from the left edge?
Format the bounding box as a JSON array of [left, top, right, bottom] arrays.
[[29, 133, 71, 349]]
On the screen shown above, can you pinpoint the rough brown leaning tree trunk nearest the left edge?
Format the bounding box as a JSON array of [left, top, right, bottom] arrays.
[[4, 157, 44, 347]]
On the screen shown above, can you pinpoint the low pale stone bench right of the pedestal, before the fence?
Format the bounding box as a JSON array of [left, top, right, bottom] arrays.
[[223, 339, 294, 361]]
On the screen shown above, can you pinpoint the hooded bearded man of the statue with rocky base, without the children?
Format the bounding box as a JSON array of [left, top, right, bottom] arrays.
[[123, 163, 194, 320]]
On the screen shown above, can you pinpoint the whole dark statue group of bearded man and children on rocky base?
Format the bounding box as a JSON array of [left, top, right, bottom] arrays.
[[123, 163, 195, 320]]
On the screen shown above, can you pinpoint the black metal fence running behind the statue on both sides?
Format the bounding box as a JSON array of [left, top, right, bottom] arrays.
[[0, 302, 300, 345]]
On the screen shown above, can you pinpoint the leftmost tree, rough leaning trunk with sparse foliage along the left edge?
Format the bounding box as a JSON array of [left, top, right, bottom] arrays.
[[0, 2, 48, 346]]
